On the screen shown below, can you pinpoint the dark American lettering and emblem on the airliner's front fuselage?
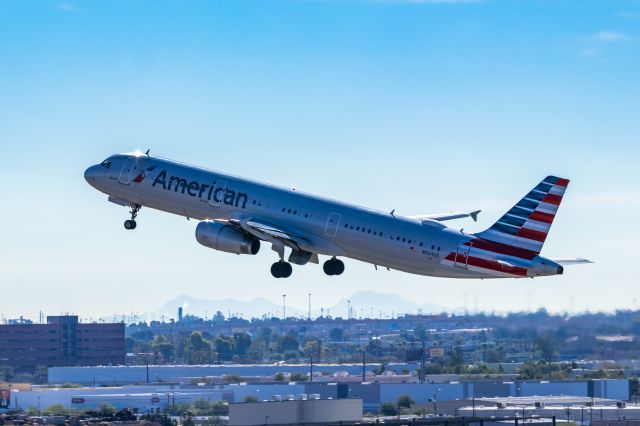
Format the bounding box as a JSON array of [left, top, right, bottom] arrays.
[[151, 169, 249, 209]]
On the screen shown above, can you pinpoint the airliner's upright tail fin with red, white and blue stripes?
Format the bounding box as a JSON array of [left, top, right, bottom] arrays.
[[476, 176, 569, 254]]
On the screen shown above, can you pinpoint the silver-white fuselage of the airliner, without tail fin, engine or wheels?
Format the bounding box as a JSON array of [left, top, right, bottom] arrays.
[[85, 154, 560, 278]]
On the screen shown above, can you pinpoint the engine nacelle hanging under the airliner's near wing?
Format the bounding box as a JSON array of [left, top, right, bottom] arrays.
[[196, 221, 260, 254]]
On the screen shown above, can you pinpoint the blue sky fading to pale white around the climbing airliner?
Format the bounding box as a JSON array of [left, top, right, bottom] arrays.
[[0, 0, 640, 318]]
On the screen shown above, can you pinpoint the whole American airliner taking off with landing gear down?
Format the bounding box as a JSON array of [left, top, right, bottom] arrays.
[[84, 151, 591, 279]]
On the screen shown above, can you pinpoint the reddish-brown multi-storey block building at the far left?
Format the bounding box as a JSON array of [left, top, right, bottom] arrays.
[[0, 315, 125, 370]]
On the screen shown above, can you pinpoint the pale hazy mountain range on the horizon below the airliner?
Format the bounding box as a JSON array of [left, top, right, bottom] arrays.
[[147, 291, 447, 319]]
